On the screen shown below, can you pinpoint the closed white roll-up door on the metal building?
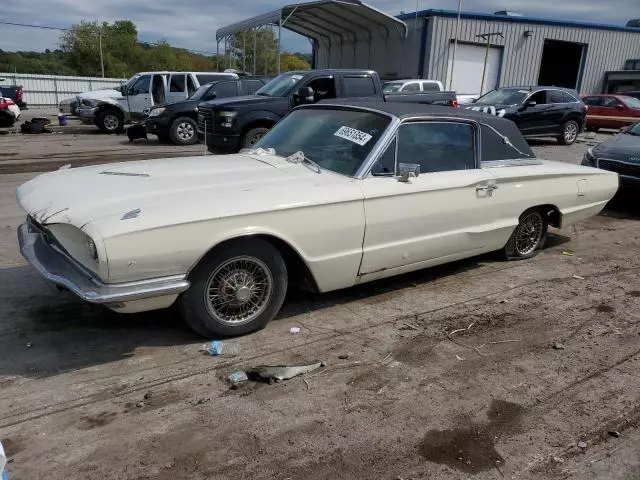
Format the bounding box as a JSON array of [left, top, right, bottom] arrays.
[[447, 43, 500, 94]]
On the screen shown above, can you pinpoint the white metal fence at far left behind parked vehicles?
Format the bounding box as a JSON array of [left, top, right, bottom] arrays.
[[0, 72, 123, 107]]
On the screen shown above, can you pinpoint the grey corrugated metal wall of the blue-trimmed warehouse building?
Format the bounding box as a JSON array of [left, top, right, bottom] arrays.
[[424, 16, 640, 93]]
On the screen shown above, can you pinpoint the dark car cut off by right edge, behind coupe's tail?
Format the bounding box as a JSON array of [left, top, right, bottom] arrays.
[[582, 122, 640, 188]]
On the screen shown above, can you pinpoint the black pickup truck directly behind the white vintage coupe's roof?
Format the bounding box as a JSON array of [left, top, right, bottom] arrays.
[[198, 69, 457, 152]]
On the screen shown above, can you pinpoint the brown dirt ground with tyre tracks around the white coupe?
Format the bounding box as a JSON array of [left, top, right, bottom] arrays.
[[0, 117, 640, 480]]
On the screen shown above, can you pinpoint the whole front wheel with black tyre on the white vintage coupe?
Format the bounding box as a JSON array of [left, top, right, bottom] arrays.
[[180, 239, 288, 338]]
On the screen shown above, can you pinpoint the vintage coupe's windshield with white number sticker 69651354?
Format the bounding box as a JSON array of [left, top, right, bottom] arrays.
[[255, 108, 391, 177]]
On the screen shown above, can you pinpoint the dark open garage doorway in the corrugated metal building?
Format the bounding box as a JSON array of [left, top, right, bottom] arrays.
[[538, 39, 585, 89]]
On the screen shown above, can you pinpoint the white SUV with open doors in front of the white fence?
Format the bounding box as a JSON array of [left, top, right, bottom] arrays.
[[76, 72, 238, 133]]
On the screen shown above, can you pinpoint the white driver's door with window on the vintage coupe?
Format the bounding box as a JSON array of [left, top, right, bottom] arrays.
[[360, 121, 495, 280]]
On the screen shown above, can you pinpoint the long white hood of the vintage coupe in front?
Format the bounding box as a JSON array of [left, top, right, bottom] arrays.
[[17, 154, 362, 237]]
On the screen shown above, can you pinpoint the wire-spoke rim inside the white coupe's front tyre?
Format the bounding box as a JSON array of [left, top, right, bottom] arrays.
[[204, 256, 273, 326]]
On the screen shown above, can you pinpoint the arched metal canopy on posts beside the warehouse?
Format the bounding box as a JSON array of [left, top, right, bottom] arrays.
[[216, 0, 407, 73]]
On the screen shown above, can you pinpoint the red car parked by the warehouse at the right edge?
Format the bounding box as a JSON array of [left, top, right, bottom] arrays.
[[582, 95, 640, 131]]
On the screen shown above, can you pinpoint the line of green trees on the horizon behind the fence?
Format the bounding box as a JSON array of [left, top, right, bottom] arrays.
[[0, 20, 311, 78]]
